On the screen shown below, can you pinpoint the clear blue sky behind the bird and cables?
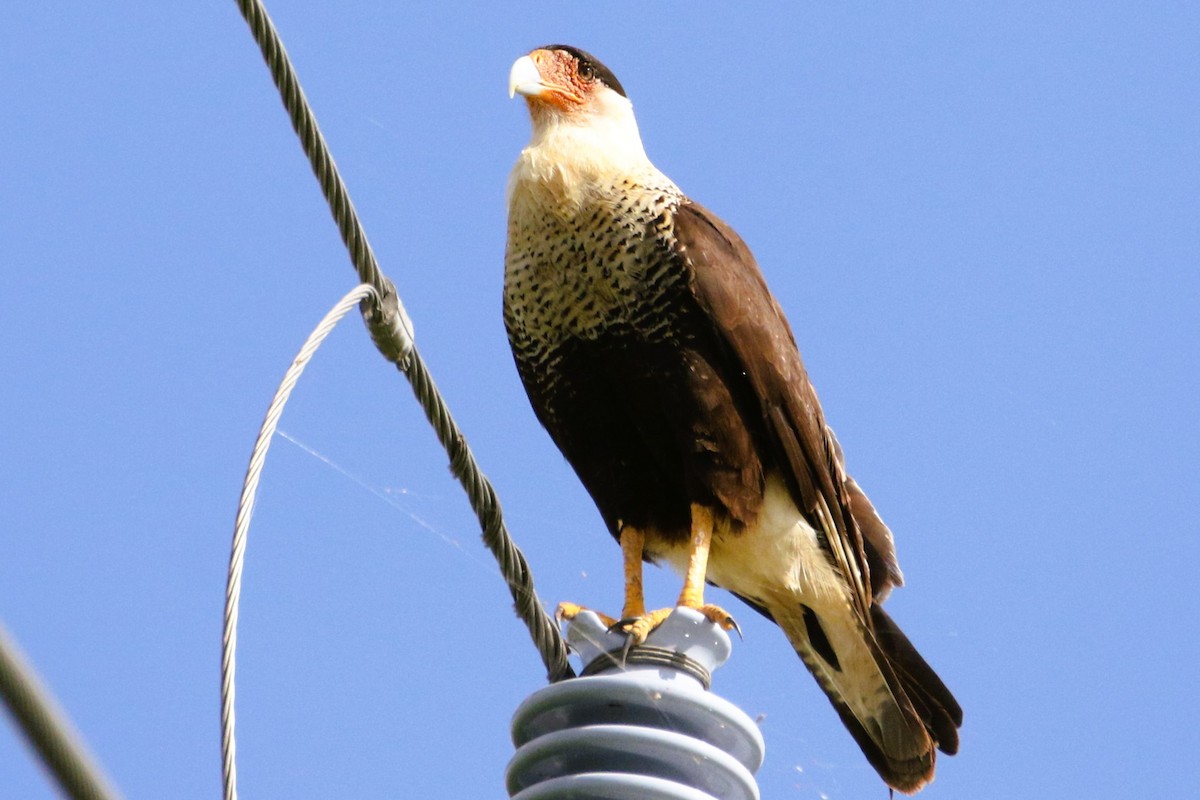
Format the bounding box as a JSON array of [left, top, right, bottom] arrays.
[[0, 0, 1200, 800]]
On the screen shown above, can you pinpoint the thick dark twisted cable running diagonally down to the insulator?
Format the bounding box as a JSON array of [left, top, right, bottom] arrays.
[[238, 0, 575, 681]]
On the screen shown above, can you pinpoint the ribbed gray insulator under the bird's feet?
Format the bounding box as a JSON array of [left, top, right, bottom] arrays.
[[505, 608, 764, 800]]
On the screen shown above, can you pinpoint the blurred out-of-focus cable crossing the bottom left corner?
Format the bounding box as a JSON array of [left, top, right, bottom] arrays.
[[0, 624, 121, 800]]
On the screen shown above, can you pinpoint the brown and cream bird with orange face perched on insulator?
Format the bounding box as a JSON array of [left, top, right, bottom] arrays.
[[503, 44, 962, 793]]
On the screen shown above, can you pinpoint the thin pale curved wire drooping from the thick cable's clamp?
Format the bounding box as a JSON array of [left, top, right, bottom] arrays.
[[221, 283, 376, 800]]
